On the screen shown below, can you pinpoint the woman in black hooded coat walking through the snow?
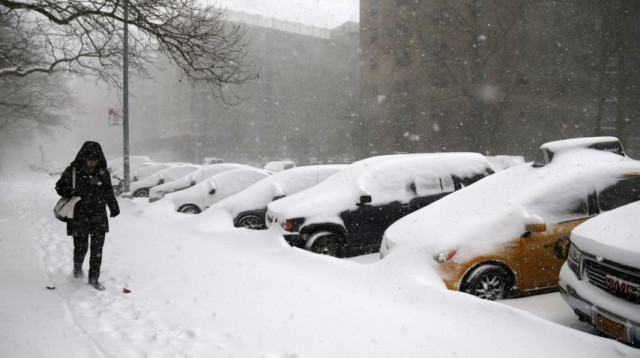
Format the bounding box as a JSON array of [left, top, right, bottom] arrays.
[[56, 142, 120, 291]]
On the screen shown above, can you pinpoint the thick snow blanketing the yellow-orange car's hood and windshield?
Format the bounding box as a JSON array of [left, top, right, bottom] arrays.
[[385, 149, 640, 261]]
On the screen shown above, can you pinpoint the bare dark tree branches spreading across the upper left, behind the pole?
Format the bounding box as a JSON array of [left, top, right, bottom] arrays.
[[0, 0, 255, 102]]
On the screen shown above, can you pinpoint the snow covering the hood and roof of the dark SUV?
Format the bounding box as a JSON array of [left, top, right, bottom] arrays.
[[269, 153, 491, 222]]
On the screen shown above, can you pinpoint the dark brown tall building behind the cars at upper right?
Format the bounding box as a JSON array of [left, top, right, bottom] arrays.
[[360, 0, 640, 156]]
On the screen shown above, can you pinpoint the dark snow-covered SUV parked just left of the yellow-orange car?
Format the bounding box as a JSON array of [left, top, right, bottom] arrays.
[[267, 153, 494, 256]]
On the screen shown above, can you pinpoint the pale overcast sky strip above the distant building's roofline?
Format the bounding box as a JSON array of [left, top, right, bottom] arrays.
[[210, 0, 360, 28]]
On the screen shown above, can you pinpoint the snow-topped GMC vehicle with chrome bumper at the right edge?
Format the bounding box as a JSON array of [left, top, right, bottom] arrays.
[[560, 201, 640, 346]]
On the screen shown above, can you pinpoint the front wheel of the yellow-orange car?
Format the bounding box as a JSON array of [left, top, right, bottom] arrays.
[[461, 264, 511, 301]]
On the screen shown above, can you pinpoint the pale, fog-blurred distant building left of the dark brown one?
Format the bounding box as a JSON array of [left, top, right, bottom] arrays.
[[138, 12, 360, 165]]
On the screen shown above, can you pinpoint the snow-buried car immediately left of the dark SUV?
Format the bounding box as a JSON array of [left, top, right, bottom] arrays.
[[211, 164, 346, 229]]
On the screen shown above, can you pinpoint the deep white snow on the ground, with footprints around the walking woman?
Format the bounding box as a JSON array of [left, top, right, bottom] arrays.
[[0, 173, 640, 358]]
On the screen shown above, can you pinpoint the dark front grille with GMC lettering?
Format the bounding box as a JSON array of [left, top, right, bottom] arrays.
[[584, 259, 640, 303]]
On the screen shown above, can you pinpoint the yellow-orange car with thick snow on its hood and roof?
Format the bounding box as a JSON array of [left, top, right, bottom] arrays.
[[380, 138, 640, 299]]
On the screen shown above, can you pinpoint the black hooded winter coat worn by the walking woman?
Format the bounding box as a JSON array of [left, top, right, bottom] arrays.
[[56, 142, 120, 236]]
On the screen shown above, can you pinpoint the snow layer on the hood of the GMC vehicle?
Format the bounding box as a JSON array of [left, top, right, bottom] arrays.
[[571, 202, 640, 268]]
